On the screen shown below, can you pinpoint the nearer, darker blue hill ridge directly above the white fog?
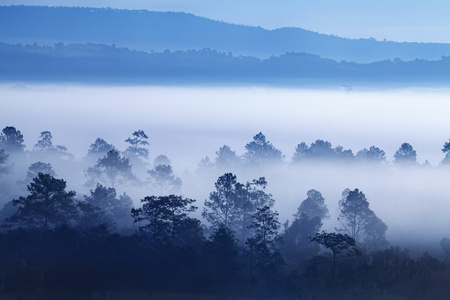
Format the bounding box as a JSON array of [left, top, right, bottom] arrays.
[[0, 43, 450, 86]]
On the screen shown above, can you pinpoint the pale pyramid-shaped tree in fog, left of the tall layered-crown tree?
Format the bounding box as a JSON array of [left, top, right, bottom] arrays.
[[85, 149, 138, 189]]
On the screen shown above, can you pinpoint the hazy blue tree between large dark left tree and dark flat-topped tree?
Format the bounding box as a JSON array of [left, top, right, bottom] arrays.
[[84, 184, 133, 230]]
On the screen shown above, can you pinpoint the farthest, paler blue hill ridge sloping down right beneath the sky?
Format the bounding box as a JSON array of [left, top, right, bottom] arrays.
[[0, 6, 450, 63]]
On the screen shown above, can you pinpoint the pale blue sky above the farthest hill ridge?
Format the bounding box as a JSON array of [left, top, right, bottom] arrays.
[[2, 0, 450, 43]]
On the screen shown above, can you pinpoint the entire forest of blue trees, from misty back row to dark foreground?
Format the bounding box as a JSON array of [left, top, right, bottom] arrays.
[[0, 126, 450, 299]]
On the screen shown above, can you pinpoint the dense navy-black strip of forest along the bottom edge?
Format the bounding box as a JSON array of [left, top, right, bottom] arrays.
[[0, 225, 450, 299]]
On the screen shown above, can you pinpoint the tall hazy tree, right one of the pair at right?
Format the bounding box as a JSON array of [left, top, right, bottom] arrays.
[[338, 189, 387, 250]]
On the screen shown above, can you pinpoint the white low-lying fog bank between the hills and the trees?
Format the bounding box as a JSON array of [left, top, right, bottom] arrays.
[[0, 85, 450, 254]]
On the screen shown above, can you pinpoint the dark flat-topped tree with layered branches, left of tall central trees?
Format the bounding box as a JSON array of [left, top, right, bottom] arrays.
[[131, 195, 200, 242]]
